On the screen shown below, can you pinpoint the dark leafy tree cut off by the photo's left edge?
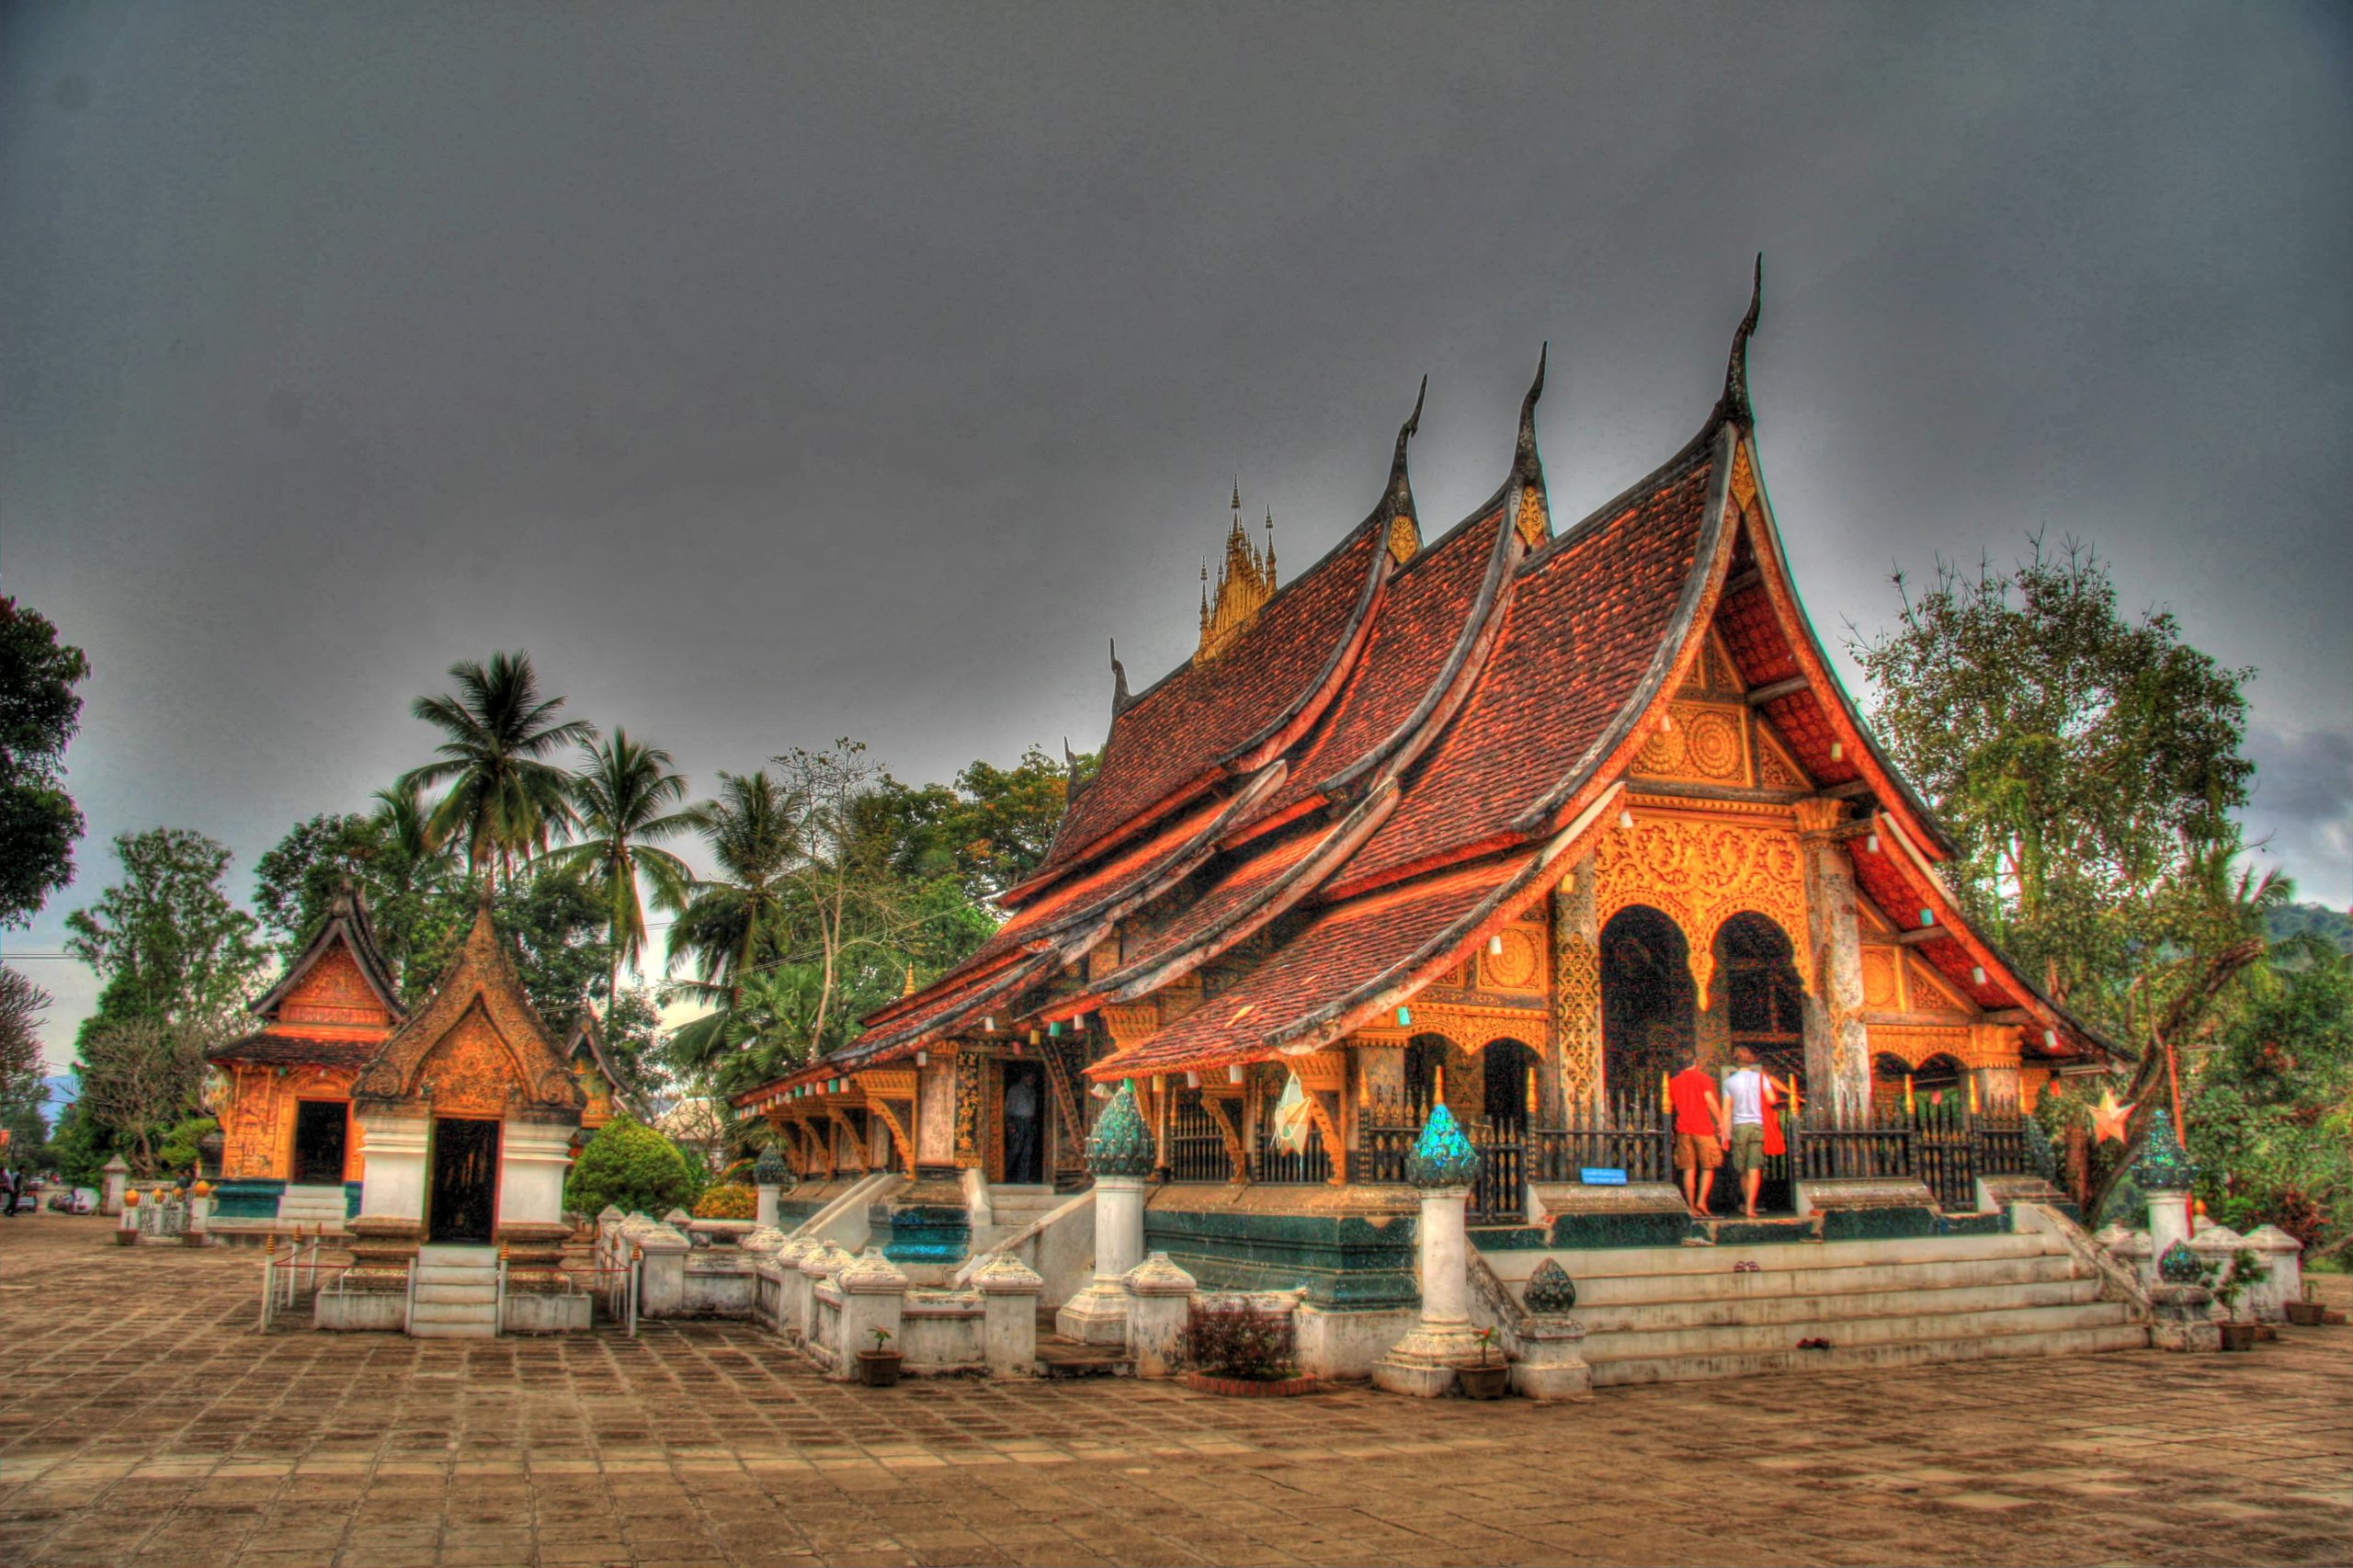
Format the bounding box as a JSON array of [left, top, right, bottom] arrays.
[[0, 598, 89, 926]]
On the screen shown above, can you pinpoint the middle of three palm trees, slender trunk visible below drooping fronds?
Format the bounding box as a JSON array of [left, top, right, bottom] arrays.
[[543, 728, 699, 1019]]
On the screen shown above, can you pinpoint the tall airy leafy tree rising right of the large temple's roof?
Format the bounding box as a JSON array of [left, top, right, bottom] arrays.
[[1854, 540, 2254, 1012]]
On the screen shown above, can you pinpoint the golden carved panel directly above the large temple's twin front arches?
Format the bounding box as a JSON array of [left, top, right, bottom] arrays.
[[1593, 814, 1814, 996]]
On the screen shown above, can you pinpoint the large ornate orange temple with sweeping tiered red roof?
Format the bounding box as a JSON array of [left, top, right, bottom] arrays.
[[715, 268, 2122, 1380]]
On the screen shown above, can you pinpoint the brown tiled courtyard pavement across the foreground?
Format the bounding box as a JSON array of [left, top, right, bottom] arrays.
[[0, 1215, 2353, 1568]]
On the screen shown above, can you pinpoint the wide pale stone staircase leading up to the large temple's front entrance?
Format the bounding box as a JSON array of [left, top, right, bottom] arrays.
[[1483, 1233, 2148, 1387]]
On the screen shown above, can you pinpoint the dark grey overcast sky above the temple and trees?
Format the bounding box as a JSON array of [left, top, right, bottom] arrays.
[[0, 3, 2353, 1062]]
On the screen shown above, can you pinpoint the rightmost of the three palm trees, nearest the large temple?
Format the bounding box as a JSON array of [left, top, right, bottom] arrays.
[[671, 767, 800, 1012]]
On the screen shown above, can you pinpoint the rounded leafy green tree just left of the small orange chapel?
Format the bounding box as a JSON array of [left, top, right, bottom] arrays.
[[66, 829, 268, 1034]]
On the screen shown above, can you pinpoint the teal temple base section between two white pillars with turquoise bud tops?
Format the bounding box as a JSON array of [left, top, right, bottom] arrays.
[[1143, 1210, 1421, 1312]]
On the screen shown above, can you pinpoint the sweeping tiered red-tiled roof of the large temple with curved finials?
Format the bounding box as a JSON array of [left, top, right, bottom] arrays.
[[748, 258, 2101, 1102]]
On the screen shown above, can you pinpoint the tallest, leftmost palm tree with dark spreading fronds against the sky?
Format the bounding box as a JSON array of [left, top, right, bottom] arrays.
[[400, 653, 596, 902]]
